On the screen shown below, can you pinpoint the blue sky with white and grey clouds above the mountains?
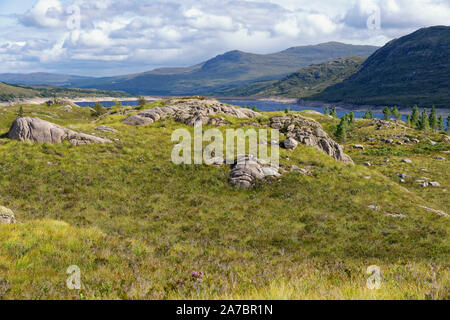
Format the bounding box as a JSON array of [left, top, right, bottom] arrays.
[[0, 0, 450, 76]]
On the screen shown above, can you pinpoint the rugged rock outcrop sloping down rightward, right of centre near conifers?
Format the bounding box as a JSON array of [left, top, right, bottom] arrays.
[[270, 115, 353, 164]]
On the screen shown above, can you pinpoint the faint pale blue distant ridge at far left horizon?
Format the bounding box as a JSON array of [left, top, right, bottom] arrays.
[[0, 72, 91, 87]]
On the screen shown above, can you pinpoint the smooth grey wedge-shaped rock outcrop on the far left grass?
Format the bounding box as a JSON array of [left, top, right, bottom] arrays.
[[8, 117, 111, 146]]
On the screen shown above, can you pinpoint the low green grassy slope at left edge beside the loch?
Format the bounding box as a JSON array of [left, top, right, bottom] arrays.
[[0, 82, 131, 101]]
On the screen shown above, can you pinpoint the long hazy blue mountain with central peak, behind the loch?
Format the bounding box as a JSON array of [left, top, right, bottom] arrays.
[[69, 42, 378, 95]]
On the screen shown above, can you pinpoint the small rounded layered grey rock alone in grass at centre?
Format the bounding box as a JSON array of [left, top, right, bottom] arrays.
[[229, 155, 281, 189]]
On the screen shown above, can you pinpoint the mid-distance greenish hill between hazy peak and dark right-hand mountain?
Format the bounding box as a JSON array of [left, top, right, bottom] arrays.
[[214, 57, 365, 99]]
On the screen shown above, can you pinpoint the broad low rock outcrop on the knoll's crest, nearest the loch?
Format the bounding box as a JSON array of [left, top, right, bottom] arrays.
[[123, 99, 260, 126]]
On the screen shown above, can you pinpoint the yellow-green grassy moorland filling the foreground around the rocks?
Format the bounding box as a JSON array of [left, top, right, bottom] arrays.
[[0, 102, 450, 299]]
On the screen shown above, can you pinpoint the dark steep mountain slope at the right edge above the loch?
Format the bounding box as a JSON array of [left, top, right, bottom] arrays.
[[311, 26, 450, 107]]
